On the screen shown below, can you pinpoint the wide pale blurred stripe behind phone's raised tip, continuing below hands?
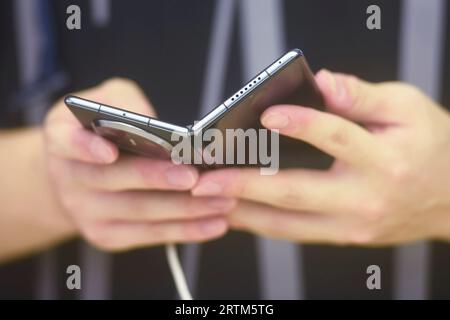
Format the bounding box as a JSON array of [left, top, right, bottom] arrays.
[[240, 0, 303, 299]]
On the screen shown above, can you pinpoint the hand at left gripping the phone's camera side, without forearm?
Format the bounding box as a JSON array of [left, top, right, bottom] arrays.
[[44, 79, 236, 250]]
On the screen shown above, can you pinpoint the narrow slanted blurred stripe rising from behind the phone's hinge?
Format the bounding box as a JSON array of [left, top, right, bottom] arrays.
[[183, 0, 236, 297]]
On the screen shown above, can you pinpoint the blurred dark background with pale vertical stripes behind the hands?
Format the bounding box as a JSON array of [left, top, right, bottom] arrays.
[[0, 0, 450, 299]]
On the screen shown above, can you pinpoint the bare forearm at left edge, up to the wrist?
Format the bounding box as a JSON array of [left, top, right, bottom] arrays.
[[0, 128, 76, 262]]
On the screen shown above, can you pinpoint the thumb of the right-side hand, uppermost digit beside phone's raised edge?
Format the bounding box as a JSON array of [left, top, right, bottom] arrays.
[[316, 69, 398, 124]]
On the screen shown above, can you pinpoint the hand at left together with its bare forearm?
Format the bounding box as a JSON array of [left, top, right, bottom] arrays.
[[0, 79, 236, 262]]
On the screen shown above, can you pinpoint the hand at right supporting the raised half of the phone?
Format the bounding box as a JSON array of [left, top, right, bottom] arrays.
[[192, 70, 450, 245]]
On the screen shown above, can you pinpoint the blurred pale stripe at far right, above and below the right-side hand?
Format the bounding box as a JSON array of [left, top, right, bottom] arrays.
[[394, 0, 445, 299]]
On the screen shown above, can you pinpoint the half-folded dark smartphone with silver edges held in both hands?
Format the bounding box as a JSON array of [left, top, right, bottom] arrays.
[[65, 49, 332, 169]]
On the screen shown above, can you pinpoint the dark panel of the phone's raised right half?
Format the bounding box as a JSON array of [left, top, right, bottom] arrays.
[[199, 50, 332, 168]]
